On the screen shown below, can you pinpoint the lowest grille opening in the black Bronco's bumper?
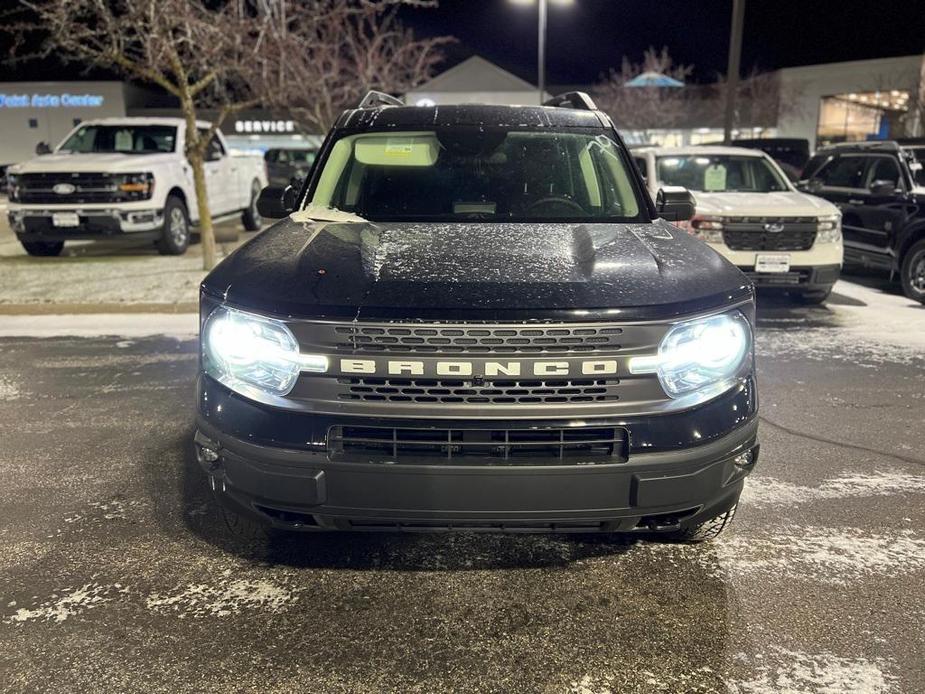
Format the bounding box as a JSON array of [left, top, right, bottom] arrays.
[[327, 426, 629, 465]]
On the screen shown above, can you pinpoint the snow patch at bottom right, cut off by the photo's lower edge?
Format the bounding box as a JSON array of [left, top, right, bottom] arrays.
[[729, 648, 896, 694]]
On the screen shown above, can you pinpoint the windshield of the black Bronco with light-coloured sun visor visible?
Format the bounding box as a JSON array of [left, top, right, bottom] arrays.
[[309, 127, 645, 222]]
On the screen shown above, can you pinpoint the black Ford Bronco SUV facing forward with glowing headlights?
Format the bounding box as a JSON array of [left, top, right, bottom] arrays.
[[195, 93, 758, 541]]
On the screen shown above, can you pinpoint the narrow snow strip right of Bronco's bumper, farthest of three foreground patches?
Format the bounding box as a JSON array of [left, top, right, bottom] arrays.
[[742, 470, 925, 506]]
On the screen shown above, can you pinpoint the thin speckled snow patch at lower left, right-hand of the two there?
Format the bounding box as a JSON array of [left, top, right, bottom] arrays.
[[146, 579, 298, 619]]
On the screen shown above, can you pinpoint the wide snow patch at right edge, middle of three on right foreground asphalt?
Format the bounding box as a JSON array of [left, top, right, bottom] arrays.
[[710, 526, 925, 586]]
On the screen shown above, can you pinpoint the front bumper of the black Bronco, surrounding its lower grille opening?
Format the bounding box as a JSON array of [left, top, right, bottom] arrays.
[[196, 377, 758, 532]]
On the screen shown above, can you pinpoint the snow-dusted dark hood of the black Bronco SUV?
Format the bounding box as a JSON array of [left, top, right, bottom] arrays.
[[202, 218, 750, 318]]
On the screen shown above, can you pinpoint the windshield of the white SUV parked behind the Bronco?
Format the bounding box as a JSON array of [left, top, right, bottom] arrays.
[[658, 154, 789, 193]]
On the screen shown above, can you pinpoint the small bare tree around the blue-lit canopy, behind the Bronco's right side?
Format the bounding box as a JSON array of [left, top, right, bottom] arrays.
[[595, 47, 694, 138]]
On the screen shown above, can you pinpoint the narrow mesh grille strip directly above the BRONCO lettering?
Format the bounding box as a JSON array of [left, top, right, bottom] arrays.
[[335, 324, 623, 354]]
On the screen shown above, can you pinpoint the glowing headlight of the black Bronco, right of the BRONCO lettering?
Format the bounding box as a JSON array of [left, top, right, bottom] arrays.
[[629, 311, 752, 398]]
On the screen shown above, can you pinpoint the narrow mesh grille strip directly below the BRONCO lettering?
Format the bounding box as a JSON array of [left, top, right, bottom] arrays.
[[337, 377, 620, 404]]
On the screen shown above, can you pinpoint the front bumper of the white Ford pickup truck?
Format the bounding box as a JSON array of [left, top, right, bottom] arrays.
[[8, 207, 164, 242]]
